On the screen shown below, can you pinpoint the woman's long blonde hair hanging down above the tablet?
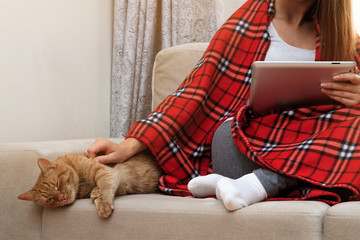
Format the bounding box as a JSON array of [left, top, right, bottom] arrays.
[[314, 0, 356, 61]]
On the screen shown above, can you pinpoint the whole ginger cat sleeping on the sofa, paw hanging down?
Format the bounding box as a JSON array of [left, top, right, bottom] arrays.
[[18, 152, 161, 218]]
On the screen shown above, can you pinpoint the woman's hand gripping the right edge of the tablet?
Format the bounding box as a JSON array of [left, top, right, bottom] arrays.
[[321, 68, 360, 107]]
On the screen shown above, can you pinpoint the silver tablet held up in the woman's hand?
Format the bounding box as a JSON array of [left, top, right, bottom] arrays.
[[249, 61, 356, 115]]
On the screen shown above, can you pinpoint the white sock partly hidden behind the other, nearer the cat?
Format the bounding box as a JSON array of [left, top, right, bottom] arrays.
[[188, 173, 223, 197]]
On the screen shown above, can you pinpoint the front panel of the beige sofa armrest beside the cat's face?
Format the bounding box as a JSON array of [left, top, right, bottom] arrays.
[[0, 147, 42, 240]]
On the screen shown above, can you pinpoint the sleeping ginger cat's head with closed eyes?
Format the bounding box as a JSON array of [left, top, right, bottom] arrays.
[[18, 158, 79, 208]]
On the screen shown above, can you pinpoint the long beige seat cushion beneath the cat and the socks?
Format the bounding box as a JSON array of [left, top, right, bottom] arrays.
[[42, 194, 329, 240]]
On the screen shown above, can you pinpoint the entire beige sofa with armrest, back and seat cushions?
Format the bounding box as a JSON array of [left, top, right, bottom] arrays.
[[0, 44, 360, 240]]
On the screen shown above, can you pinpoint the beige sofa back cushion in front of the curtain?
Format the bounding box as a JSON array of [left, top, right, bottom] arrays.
[[152, 43, 209, 109]]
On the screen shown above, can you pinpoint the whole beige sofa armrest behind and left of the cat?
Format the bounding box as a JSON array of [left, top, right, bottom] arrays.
[[0, 139, 121, 239]]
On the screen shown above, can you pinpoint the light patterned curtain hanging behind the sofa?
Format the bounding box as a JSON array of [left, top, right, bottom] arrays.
[[111, 0, 216, 137]]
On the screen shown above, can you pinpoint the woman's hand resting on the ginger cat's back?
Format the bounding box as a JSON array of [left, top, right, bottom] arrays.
[[85, 138, 147, 163]]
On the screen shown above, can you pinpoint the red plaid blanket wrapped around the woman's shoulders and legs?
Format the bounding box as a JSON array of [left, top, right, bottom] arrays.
[[127, 0, 360, 203]]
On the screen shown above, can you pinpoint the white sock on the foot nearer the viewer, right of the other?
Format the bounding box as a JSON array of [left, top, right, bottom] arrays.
[[216, 173, 267, 211]]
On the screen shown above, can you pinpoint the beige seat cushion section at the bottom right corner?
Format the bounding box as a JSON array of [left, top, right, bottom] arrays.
[[324, 202, 360, 240]]
